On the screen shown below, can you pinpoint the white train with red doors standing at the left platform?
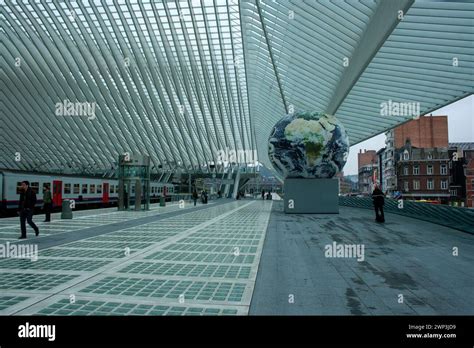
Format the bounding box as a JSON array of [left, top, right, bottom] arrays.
[[0, 171, 177, 216]]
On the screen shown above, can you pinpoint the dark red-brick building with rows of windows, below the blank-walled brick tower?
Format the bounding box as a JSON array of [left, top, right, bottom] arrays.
[[396, 140, 450, 203]]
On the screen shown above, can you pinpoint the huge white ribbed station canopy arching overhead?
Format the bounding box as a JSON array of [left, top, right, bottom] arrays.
[[0, 0, 474, 173]]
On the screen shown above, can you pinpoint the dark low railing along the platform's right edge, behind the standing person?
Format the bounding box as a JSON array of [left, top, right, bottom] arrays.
[[339, 196, 474, 234]]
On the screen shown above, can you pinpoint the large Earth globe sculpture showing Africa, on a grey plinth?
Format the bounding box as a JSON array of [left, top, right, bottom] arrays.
[[268, 112, 349, 178]]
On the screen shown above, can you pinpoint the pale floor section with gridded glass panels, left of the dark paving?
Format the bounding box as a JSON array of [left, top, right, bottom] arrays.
[[0, 200, 272, 315]]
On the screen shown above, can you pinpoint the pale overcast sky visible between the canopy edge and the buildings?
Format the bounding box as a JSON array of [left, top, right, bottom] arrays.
[[344, 95, 474, 175]]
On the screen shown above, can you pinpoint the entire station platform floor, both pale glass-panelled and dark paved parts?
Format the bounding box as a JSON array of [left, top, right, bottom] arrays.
[[0, 199, 474, 315]]
